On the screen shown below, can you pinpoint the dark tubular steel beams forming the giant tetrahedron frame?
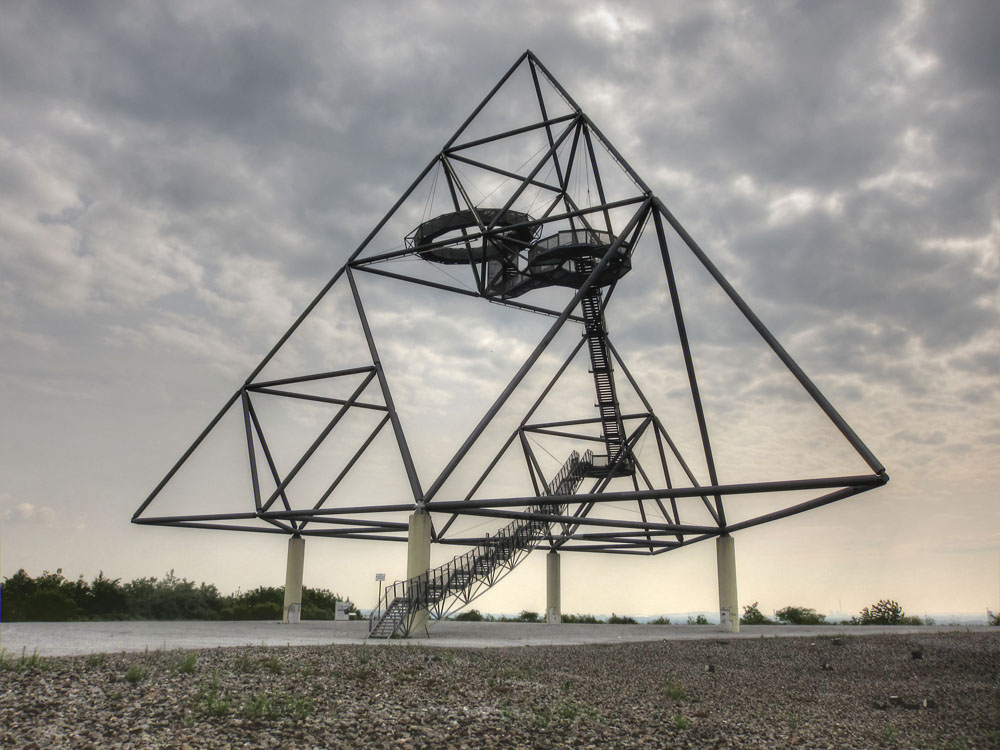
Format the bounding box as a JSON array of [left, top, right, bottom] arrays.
[[132, 50, 888, 555]]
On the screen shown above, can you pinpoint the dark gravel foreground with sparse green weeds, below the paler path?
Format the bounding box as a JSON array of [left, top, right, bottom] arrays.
[[0, 632, 1000, 750]]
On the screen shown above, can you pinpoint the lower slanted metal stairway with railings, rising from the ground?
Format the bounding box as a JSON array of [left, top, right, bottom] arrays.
[[368, 451, 594, 638]]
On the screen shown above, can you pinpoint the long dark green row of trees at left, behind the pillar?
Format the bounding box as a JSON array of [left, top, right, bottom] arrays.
[[0, 568, 358, 622]]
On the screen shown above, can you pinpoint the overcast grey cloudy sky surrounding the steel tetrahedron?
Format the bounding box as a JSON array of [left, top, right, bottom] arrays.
[[0, 0, 1000, 614]]
